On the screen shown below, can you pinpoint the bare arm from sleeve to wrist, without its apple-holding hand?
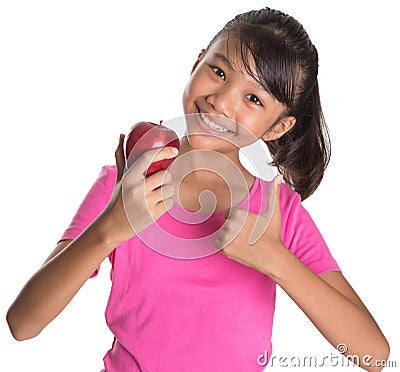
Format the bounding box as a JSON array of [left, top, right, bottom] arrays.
[[7, 219, 119, 341]]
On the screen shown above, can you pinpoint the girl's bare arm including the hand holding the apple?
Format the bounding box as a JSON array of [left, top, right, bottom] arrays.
[[7, 136, 176, 340]]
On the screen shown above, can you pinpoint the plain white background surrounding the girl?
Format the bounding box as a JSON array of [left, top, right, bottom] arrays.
[[0, 0, 400, 372]]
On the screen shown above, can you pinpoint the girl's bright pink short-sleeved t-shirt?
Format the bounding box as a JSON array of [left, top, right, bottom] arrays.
[[61, 166, 340, 372]]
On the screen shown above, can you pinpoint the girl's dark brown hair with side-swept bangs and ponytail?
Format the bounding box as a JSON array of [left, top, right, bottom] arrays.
[[207, 8, 331, 200]]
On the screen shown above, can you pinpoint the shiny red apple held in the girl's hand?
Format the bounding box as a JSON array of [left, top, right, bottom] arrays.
[[125, 121, 179, 177]]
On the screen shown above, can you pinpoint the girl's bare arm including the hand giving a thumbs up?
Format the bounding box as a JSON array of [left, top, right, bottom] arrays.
[[216, 177, 389, 371]]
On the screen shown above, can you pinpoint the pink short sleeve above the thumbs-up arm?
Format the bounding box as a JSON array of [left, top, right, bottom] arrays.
[[281, 185, 340, 275]]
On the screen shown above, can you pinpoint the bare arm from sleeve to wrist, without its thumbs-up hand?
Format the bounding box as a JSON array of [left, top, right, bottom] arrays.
[[268, 245, 389, 371]]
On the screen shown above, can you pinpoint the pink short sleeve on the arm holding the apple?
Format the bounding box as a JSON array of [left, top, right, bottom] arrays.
[[60, 166, 116, 276]]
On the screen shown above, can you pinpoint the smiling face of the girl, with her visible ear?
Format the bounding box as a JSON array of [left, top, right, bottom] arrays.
[[183, 38, 296, 152]]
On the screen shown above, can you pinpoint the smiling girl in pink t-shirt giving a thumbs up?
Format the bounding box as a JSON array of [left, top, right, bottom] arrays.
[[7, 8, 389, 372]]
